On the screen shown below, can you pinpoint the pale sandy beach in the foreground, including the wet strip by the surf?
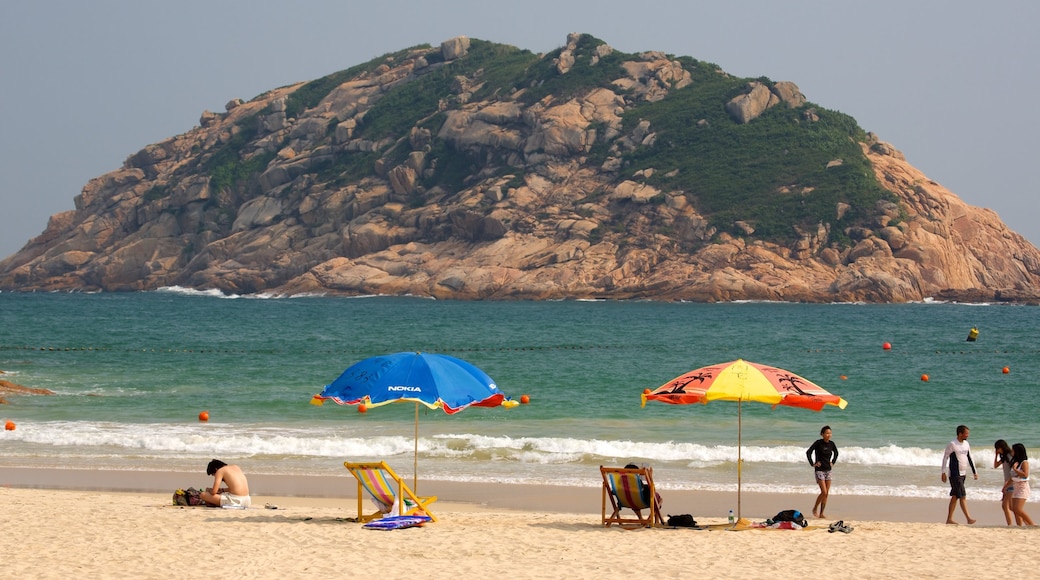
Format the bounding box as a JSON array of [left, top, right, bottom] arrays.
[[0, 468, 1040, 579]]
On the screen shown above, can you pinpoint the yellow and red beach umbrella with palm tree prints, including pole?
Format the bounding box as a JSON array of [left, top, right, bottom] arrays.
[[643, 359, 849, 517]]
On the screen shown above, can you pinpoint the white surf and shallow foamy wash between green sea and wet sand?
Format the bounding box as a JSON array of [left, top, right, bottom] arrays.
[[4, 421, 1000, 499]]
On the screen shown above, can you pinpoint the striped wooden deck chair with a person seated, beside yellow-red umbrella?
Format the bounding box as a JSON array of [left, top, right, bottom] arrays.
[[599, 466, 665, 529]]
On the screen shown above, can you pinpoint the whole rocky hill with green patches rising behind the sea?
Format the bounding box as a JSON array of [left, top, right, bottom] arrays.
[[0, 34, 1040, 301]]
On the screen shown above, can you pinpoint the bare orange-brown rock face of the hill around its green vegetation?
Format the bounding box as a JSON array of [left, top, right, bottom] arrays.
[[0, 34, 1040, 301]]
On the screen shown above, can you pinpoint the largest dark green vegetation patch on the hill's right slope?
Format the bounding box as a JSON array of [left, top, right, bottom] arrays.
[[625, 59, 895, 242]]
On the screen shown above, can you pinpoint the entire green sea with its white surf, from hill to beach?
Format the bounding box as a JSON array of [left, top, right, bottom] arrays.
[[0, 288, 1040, 500]]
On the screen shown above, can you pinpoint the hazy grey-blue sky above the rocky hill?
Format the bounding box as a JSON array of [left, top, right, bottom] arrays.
[[0, 0, 1040, 258]]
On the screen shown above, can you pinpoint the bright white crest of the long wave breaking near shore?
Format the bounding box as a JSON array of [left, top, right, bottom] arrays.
[[4, 426, 942, 470]]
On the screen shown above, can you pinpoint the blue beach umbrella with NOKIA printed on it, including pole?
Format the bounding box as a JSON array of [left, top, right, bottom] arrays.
[[311, 352, 518, 491]]
